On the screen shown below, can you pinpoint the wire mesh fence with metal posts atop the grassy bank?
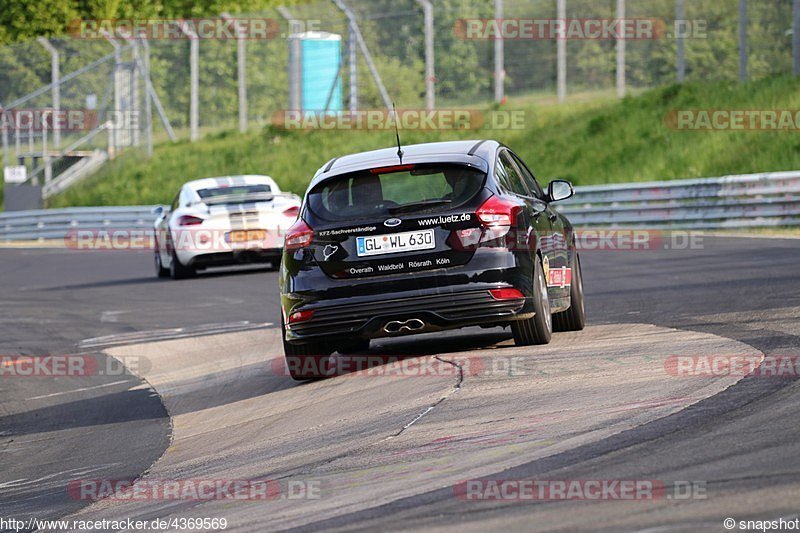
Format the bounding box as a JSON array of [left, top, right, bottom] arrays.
[[0, 0, 798, 193]]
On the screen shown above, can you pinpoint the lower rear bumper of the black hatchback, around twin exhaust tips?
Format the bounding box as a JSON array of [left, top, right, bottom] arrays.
[[286, 284, 532, 342]]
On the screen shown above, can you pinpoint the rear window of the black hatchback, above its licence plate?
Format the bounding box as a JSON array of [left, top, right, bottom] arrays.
[[308, 164, 486, 220]]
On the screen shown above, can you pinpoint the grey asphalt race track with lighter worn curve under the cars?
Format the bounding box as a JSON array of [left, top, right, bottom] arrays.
[[0, 236, 800, 531]]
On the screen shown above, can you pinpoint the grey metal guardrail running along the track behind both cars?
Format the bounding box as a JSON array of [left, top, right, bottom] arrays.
[[0, 171, 800, 241]]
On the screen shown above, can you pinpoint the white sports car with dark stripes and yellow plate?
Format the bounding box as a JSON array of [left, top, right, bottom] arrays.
[[154, 176, 301, 279]]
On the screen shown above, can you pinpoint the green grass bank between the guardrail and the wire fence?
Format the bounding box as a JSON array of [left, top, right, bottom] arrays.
[[49, 77, 800, 207]]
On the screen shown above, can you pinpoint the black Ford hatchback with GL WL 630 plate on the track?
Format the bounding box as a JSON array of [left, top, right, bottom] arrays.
[[280, 141, 584, 377]]
